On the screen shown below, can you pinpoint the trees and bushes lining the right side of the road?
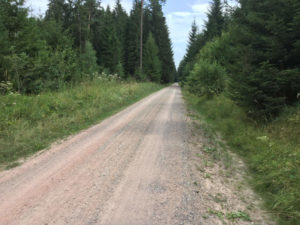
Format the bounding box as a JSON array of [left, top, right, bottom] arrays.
[[178, 0, 300, 120]]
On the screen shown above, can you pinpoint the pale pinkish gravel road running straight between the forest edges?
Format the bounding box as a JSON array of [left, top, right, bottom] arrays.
[[0, 86, 272, 225]]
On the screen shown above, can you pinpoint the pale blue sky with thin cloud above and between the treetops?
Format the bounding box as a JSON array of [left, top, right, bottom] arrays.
[[26, 0, 238, 66]]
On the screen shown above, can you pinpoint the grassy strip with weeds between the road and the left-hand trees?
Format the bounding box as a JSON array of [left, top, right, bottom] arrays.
[[0, 81, 163, 168]]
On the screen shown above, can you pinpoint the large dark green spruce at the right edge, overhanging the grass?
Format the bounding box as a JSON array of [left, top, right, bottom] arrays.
[[229, 0, 300, 119]]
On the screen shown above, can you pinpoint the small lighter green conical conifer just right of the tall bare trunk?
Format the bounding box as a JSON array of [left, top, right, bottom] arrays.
[[143, 32, 161, 83]]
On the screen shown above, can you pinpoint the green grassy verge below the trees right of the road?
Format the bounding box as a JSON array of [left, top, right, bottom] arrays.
[[184, 92, 300, 225]]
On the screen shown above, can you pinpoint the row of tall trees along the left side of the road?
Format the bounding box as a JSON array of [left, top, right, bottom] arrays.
[[0, 0, 176, 94]]
